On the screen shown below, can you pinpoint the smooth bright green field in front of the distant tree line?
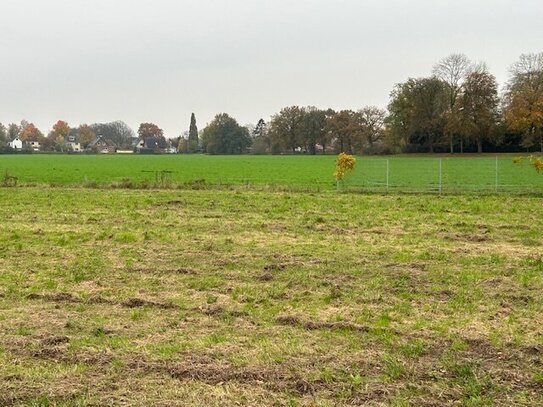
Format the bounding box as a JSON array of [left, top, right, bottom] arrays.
[[0, 155, 543, 193]]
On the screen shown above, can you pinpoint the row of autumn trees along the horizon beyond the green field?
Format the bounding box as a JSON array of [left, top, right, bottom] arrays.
[[0, 53, 543, 154]]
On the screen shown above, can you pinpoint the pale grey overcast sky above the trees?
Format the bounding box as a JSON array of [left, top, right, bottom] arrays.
[[0, 0, 543, 137]]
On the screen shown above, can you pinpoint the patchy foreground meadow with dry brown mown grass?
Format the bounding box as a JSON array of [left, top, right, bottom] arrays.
[[0, 187, 543, 407]]
